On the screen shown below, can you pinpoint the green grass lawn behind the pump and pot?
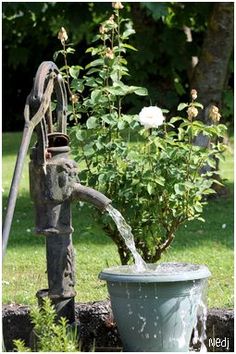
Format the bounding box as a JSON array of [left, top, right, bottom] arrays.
[[2, 133, 234, 308]]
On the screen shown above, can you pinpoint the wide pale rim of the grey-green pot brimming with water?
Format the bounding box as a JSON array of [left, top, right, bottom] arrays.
[[99, 262, 211, 283]]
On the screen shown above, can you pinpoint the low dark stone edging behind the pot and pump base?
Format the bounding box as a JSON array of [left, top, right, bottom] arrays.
[[2, 301, 234, 352]]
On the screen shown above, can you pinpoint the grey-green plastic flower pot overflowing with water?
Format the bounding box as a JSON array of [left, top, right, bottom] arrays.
[[99, 263, 211, 352]]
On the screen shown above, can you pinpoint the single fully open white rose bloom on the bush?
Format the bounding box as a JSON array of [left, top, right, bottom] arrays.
[[139, 106, 165, 129]]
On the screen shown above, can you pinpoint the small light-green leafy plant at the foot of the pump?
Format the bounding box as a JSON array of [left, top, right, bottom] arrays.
[[14, 298, 78, 352]]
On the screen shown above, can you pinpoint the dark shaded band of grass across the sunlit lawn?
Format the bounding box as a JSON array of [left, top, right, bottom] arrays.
[[3, 183, 234, 250]]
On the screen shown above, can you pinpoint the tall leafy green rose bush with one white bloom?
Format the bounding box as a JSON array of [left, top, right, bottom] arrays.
[[57, 3, 226, 264]]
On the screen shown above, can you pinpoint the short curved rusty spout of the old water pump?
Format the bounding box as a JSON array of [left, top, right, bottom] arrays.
[[71, 183, 111, 211]]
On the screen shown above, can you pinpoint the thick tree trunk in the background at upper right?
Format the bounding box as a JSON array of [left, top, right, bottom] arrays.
[[191, 2, 234, 123]]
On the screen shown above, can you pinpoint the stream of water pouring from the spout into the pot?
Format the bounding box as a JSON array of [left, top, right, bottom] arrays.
[[106, 204, 147, 272]]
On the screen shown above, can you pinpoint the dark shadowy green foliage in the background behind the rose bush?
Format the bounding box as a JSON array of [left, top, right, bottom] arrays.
[[2, 2, 233, 131]]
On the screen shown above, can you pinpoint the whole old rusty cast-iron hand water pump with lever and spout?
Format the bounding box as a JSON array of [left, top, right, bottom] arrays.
[[3, 61, 111, 324]]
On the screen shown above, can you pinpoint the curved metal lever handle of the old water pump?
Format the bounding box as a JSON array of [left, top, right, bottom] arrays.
[[2, 61, 67, 256]]
